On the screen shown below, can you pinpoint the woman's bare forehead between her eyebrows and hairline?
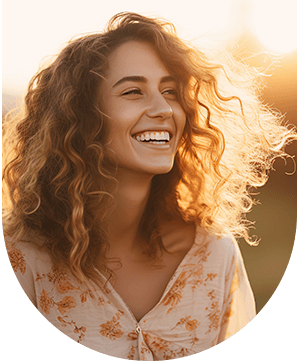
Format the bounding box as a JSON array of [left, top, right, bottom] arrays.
[[107, 41, 170, 82]]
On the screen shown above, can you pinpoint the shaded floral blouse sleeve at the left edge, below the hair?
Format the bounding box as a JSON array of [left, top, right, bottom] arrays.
[[5, 239, 37, 307]]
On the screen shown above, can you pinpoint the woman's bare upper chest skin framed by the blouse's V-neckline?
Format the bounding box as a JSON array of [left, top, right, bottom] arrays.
[[106, 224, 195, 321]]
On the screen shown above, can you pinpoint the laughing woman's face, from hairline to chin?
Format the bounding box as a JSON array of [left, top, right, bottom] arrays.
[[100, 41, 186, 176]]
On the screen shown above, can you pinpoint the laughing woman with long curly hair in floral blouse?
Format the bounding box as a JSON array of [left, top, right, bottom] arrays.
[[4, 13, 295, 361]]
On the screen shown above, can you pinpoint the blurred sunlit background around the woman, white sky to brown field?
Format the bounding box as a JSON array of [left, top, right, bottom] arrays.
[[2, 0, 297, 311]]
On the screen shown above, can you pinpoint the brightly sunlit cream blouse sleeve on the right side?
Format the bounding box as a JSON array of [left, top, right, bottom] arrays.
[[218, 240, 256, 343]]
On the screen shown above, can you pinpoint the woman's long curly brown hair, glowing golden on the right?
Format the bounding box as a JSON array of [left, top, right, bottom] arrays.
[[3, 13, 296, 282]]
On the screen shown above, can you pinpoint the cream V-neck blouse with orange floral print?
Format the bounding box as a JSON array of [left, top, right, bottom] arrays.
[[6, 227, 256, 361]]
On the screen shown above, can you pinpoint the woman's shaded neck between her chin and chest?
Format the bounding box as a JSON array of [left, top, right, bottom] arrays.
[[107, 170, 153, 256]]
